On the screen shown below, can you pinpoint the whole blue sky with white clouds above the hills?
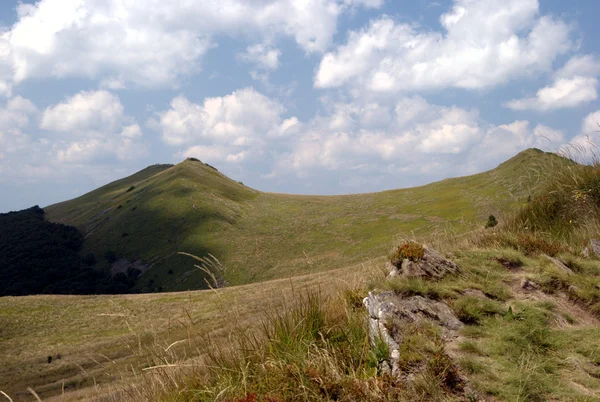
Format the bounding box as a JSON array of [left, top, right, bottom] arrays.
[[0, 0, 600, 212]]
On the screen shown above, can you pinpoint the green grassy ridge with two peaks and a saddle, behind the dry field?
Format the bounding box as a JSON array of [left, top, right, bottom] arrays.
[[45, 150, 565, 290]]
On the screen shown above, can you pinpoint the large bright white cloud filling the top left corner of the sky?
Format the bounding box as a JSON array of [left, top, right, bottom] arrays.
[[0, 0, 382, 95]]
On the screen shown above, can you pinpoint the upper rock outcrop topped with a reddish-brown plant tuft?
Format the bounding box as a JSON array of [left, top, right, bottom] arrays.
[[386, 246, 460, 279]]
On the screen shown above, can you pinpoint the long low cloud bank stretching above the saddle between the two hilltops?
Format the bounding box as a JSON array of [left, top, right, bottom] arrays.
[[151, 88, 564, 191]]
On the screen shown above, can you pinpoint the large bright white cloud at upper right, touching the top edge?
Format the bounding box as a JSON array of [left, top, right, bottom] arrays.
[[315, 0, 572, 92]]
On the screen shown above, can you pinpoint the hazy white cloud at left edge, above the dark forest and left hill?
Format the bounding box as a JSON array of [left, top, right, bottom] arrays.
[[0, 91, 147, 194]]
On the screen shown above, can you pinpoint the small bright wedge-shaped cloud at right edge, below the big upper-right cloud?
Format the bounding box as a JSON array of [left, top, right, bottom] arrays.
[[505, 55, 600, 111]]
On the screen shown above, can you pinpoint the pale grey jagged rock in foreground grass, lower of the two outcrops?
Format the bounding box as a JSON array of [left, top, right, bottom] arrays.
[[363, 292, 464, 376]]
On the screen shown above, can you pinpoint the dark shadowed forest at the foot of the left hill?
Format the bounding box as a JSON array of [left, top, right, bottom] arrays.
[[0, 206, 133, 296]]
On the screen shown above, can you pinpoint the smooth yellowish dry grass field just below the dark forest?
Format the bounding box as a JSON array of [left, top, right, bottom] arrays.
[[0, 260, 381, 400]]
